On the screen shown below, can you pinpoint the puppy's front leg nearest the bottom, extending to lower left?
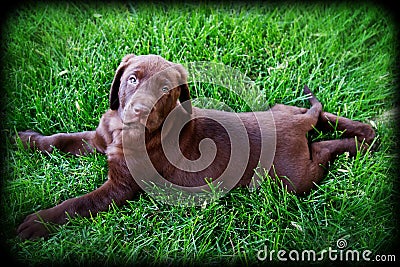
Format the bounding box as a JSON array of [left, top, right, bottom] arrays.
[[17, 158, 140, 242]]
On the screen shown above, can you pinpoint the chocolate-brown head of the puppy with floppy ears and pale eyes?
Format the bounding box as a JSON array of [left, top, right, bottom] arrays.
[[110, 54, 192, 132]]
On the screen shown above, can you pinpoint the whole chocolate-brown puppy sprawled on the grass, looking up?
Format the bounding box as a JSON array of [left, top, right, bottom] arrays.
[[17, 55, 375, 239]]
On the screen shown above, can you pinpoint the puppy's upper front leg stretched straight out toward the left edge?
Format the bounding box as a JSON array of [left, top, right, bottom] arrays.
[[18, 130, 105, 155]]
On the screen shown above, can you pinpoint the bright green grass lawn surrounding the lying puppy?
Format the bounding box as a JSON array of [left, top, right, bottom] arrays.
[[1, 3, 399, 265]]
